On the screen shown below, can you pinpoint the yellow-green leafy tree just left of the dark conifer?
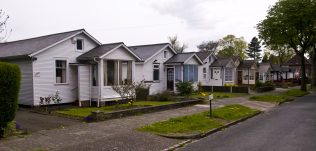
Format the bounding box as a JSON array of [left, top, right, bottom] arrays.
[[218, 35, 247, 59]]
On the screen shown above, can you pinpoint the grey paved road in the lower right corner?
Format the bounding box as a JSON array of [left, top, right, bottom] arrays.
[[181, 93, 316, 151]]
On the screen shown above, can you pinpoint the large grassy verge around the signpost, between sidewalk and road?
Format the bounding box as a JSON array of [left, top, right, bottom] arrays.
[[138, 105, 259, 135]]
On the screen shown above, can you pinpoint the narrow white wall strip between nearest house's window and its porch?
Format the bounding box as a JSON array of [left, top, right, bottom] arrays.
[[78, 65, 91, 101]]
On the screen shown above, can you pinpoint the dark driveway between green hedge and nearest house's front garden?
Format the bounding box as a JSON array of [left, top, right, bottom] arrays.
[[15, 109, 82, 132]]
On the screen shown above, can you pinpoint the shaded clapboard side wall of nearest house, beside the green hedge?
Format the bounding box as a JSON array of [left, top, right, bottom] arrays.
[[7, 59, 33, 105]]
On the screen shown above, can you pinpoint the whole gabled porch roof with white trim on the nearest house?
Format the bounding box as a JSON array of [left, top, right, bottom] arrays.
[[77, 42, 140, 60]]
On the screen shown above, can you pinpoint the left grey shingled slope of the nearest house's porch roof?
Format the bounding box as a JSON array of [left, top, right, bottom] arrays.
[[77, 42, 124, 60]]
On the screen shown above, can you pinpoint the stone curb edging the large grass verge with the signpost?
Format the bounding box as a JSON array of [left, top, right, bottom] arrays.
[[158, 111, 263, 139]]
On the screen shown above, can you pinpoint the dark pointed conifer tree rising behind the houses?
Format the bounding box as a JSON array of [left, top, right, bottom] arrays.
[[246, 37, 262, 62]]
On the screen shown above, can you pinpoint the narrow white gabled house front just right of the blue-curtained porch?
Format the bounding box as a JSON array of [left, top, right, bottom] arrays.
[[196, 51, 217, 86]]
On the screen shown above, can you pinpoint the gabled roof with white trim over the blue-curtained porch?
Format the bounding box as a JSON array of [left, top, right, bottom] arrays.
[[165, 52, 203, 64]]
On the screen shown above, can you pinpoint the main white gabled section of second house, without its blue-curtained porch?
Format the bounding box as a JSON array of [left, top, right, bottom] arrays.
[[129, 43, 177, 94]]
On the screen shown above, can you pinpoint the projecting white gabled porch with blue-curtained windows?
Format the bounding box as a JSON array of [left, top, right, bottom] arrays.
[[164, 52, 203, 91]]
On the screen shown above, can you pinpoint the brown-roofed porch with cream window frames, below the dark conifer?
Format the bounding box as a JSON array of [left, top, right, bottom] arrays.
[[237, 60, 258, 85]]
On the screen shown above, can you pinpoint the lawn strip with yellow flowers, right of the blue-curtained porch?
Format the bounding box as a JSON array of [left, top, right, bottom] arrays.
[[190, 92, 248, 100]]
